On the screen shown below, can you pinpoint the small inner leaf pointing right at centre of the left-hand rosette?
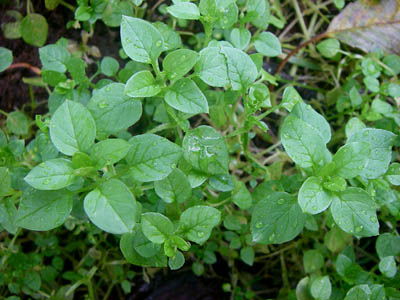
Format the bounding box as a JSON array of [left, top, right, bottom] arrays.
[[90, 139, 131, 169]]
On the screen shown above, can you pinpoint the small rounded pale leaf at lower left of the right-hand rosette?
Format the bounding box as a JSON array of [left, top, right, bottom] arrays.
[[298, 176, 335, 215]]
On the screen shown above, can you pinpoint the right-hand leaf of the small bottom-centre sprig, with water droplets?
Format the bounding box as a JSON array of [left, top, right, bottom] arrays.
[[179, 205, 221, 245]]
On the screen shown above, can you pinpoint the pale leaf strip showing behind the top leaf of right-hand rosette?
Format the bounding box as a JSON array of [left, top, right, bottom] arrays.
[[290, 102, 331, 144]]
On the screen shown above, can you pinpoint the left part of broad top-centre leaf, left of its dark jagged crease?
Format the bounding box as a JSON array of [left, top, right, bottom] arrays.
[[194, 47, 229, 87]]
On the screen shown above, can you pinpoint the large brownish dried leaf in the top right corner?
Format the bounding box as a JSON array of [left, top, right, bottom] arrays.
[[327, 0, 400, 54]]
